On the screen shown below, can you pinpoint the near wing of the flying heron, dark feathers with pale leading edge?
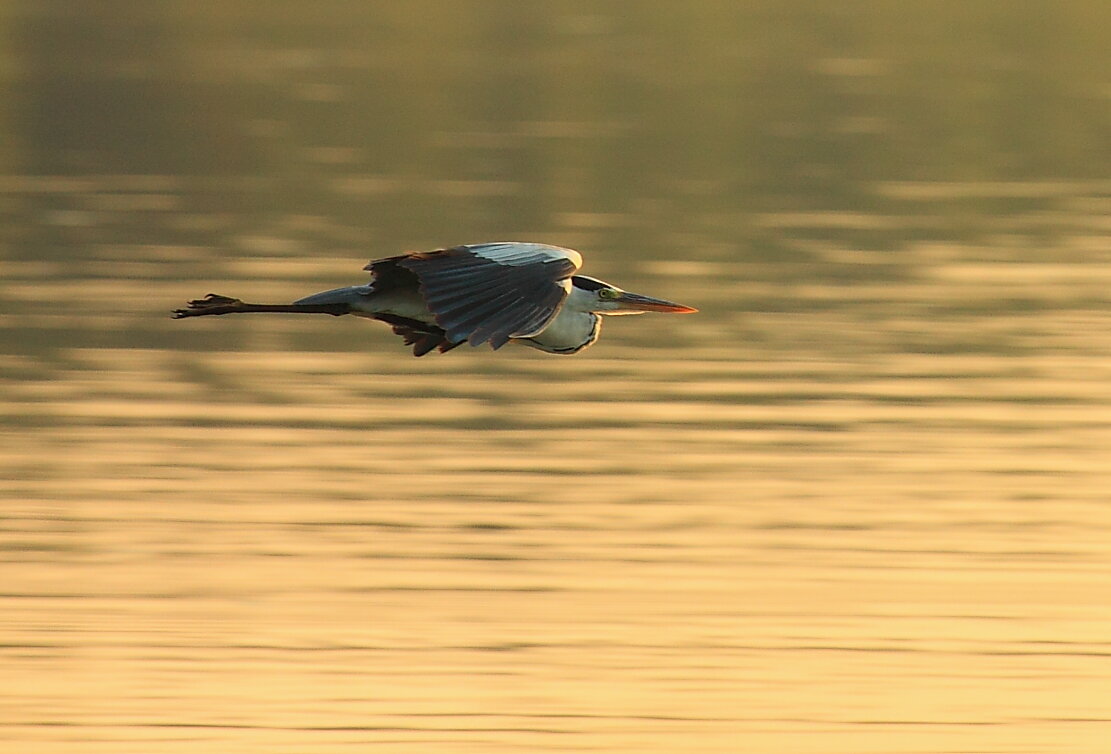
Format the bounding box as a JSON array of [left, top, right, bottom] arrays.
[[366, 242, 582, 349]]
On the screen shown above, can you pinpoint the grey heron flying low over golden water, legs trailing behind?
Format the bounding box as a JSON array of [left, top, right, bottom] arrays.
[[173, 242, 698, 356]]
